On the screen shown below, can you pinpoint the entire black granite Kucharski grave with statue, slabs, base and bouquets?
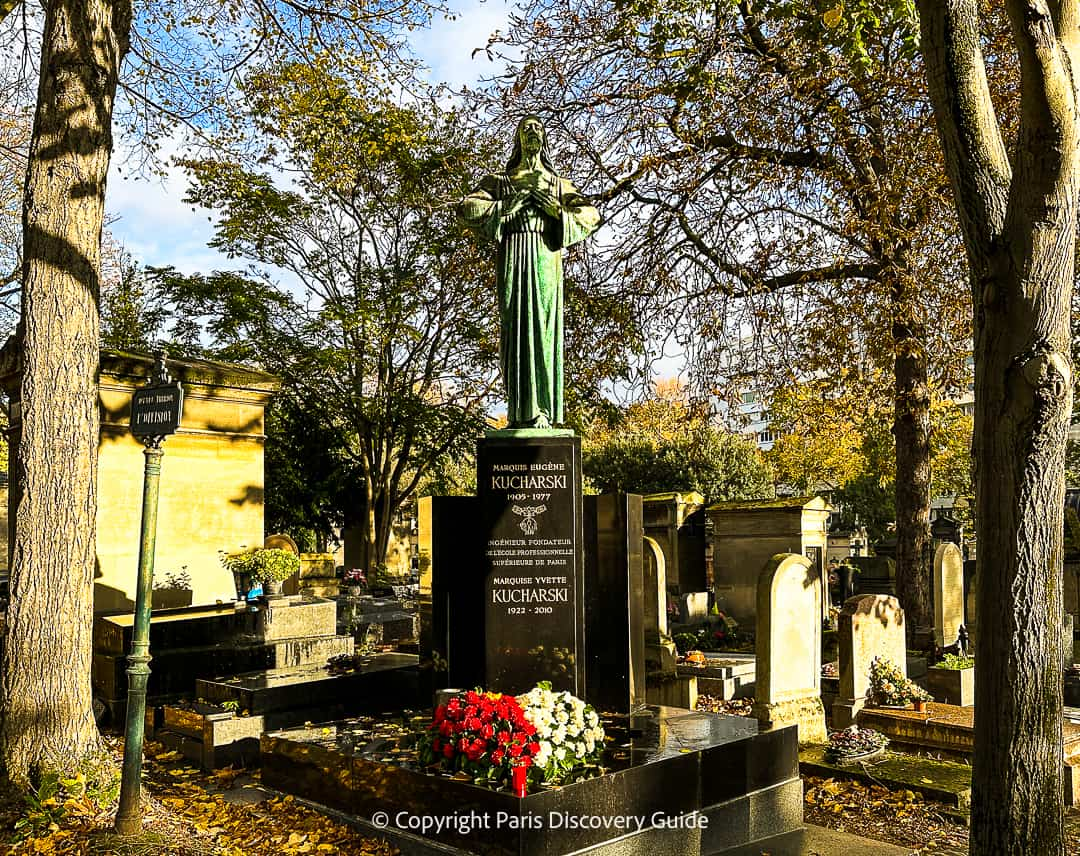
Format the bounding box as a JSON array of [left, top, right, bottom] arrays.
[[261, 117, 802, 856]]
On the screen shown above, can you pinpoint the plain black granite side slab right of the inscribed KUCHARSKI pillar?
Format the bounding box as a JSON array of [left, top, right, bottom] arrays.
[[584, 493, 645, 714]]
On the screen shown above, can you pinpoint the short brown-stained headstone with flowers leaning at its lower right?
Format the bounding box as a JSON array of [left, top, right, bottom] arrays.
[[833, 595, 907, 729]]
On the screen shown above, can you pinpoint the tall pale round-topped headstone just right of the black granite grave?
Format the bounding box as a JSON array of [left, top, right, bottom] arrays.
[[754, 553, 827, 744]]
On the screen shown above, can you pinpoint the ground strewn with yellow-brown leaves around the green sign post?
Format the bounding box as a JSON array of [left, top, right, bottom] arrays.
[[0, 739, 397, 856]]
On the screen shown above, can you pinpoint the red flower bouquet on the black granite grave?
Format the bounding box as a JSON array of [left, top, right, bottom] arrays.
[[417, 690, 540, 782]]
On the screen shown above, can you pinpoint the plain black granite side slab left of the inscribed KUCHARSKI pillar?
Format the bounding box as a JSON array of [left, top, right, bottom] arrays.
[[417, 497, 484, 692]]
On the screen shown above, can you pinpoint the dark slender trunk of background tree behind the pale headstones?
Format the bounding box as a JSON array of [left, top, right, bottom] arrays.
[[892, 275, 933, 638]]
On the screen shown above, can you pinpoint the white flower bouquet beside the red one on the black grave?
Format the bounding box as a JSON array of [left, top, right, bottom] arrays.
[[517, 681, 604, 783]]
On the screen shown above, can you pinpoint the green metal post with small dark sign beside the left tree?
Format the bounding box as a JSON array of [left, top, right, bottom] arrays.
[[114, 353, 184, 835]]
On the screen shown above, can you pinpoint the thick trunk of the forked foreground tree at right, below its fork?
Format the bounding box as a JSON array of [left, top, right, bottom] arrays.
[[971, 253, 1072, 856]]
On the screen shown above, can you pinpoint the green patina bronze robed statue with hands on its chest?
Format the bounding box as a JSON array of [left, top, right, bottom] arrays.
[[460, 116, 600, 430]]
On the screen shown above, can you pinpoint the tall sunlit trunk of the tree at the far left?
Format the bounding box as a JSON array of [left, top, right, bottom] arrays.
[[0, 0, 131, 784]]
